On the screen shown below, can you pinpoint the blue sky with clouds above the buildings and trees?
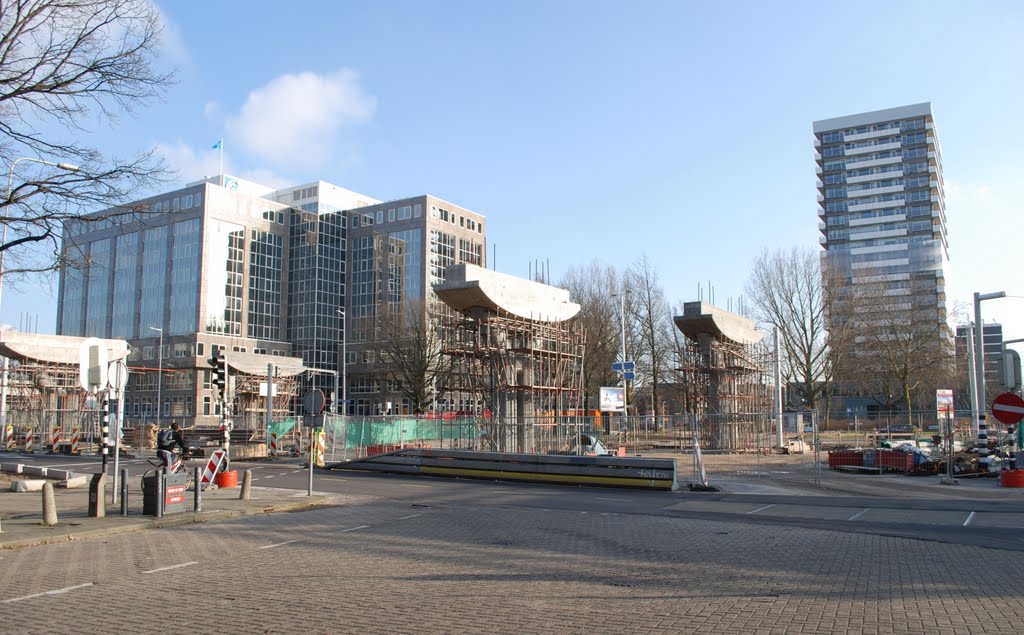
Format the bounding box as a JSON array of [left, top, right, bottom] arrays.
[[0, 0, 1024, 352]]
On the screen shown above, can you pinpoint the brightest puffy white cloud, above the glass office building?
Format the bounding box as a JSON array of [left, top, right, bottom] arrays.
[[224, 69, 377, 168]]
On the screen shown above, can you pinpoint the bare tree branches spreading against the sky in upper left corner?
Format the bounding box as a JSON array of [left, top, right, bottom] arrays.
[[0, 0, 172, 282]]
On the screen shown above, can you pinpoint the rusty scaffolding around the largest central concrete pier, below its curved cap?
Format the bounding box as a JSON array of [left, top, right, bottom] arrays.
[[441, 308, 584, 452]]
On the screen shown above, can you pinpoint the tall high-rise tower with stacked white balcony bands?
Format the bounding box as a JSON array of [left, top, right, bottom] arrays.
[[813, 103, 951, 407]]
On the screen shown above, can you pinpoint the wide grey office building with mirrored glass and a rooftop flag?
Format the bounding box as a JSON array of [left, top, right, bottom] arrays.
[[51, 176, 485, 426]]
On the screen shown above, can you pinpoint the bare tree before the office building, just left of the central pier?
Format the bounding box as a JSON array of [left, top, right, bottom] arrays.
[[375, 302, 452, 413]]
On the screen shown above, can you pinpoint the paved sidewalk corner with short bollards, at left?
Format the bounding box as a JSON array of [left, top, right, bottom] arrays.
[[0, 472, 346, 549]]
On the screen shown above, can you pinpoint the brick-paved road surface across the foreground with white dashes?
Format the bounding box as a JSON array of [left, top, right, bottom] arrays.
[[0, 494, 1024, 634]]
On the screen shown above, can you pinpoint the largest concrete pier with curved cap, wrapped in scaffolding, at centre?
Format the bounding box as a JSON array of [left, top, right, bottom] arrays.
[[434, 265, 585, 452]]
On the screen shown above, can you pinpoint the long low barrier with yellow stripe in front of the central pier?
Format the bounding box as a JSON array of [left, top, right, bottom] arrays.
[[328, 448, 679, 491]]
